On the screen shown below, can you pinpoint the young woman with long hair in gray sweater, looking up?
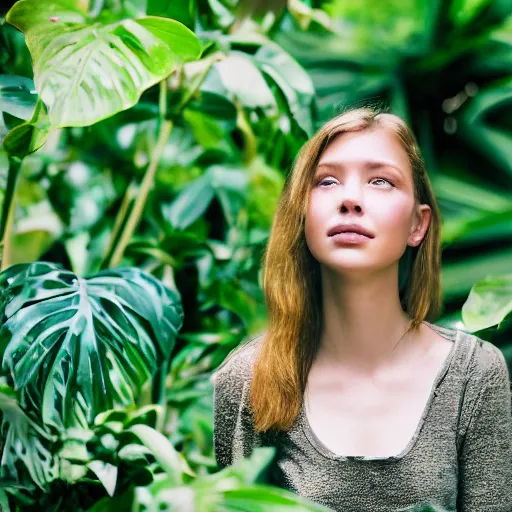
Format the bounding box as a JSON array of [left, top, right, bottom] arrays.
[[214, 108, 512, 512]]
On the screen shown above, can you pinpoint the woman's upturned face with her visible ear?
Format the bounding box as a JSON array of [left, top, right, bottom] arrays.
[[305, 127, 431, 275]]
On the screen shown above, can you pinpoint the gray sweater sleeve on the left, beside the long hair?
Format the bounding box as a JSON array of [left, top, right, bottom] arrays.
[[212, 338, 262, 469]]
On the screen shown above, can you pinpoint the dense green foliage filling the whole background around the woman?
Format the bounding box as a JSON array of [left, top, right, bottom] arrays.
[[0, 0, 512, 511]]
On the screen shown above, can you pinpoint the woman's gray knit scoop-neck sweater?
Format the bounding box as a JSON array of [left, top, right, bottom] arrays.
[[212, 322, 512, 512]]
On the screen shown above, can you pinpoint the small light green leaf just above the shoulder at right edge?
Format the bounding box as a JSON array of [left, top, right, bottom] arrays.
[[462, 274, 512, 331]]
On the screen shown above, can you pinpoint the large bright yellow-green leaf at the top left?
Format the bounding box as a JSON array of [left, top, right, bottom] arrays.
[[7, 0, 201, 128]]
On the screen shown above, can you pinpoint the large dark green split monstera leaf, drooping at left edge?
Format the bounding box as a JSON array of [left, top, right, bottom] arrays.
[[0, 262, 183, 429]]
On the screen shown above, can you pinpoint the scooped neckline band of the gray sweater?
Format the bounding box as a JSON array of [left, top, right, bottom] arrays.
[[299, 320, 462, 463]]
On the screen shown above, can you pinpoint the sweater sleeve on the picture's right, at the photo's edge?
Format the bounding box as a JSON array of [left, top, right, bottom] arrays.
[[457, 342, 512, 512]]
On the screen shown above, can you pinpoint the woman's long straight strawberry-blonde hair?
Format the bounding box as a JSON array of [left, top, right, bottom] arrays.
[[250, 107, 442, 432]]
